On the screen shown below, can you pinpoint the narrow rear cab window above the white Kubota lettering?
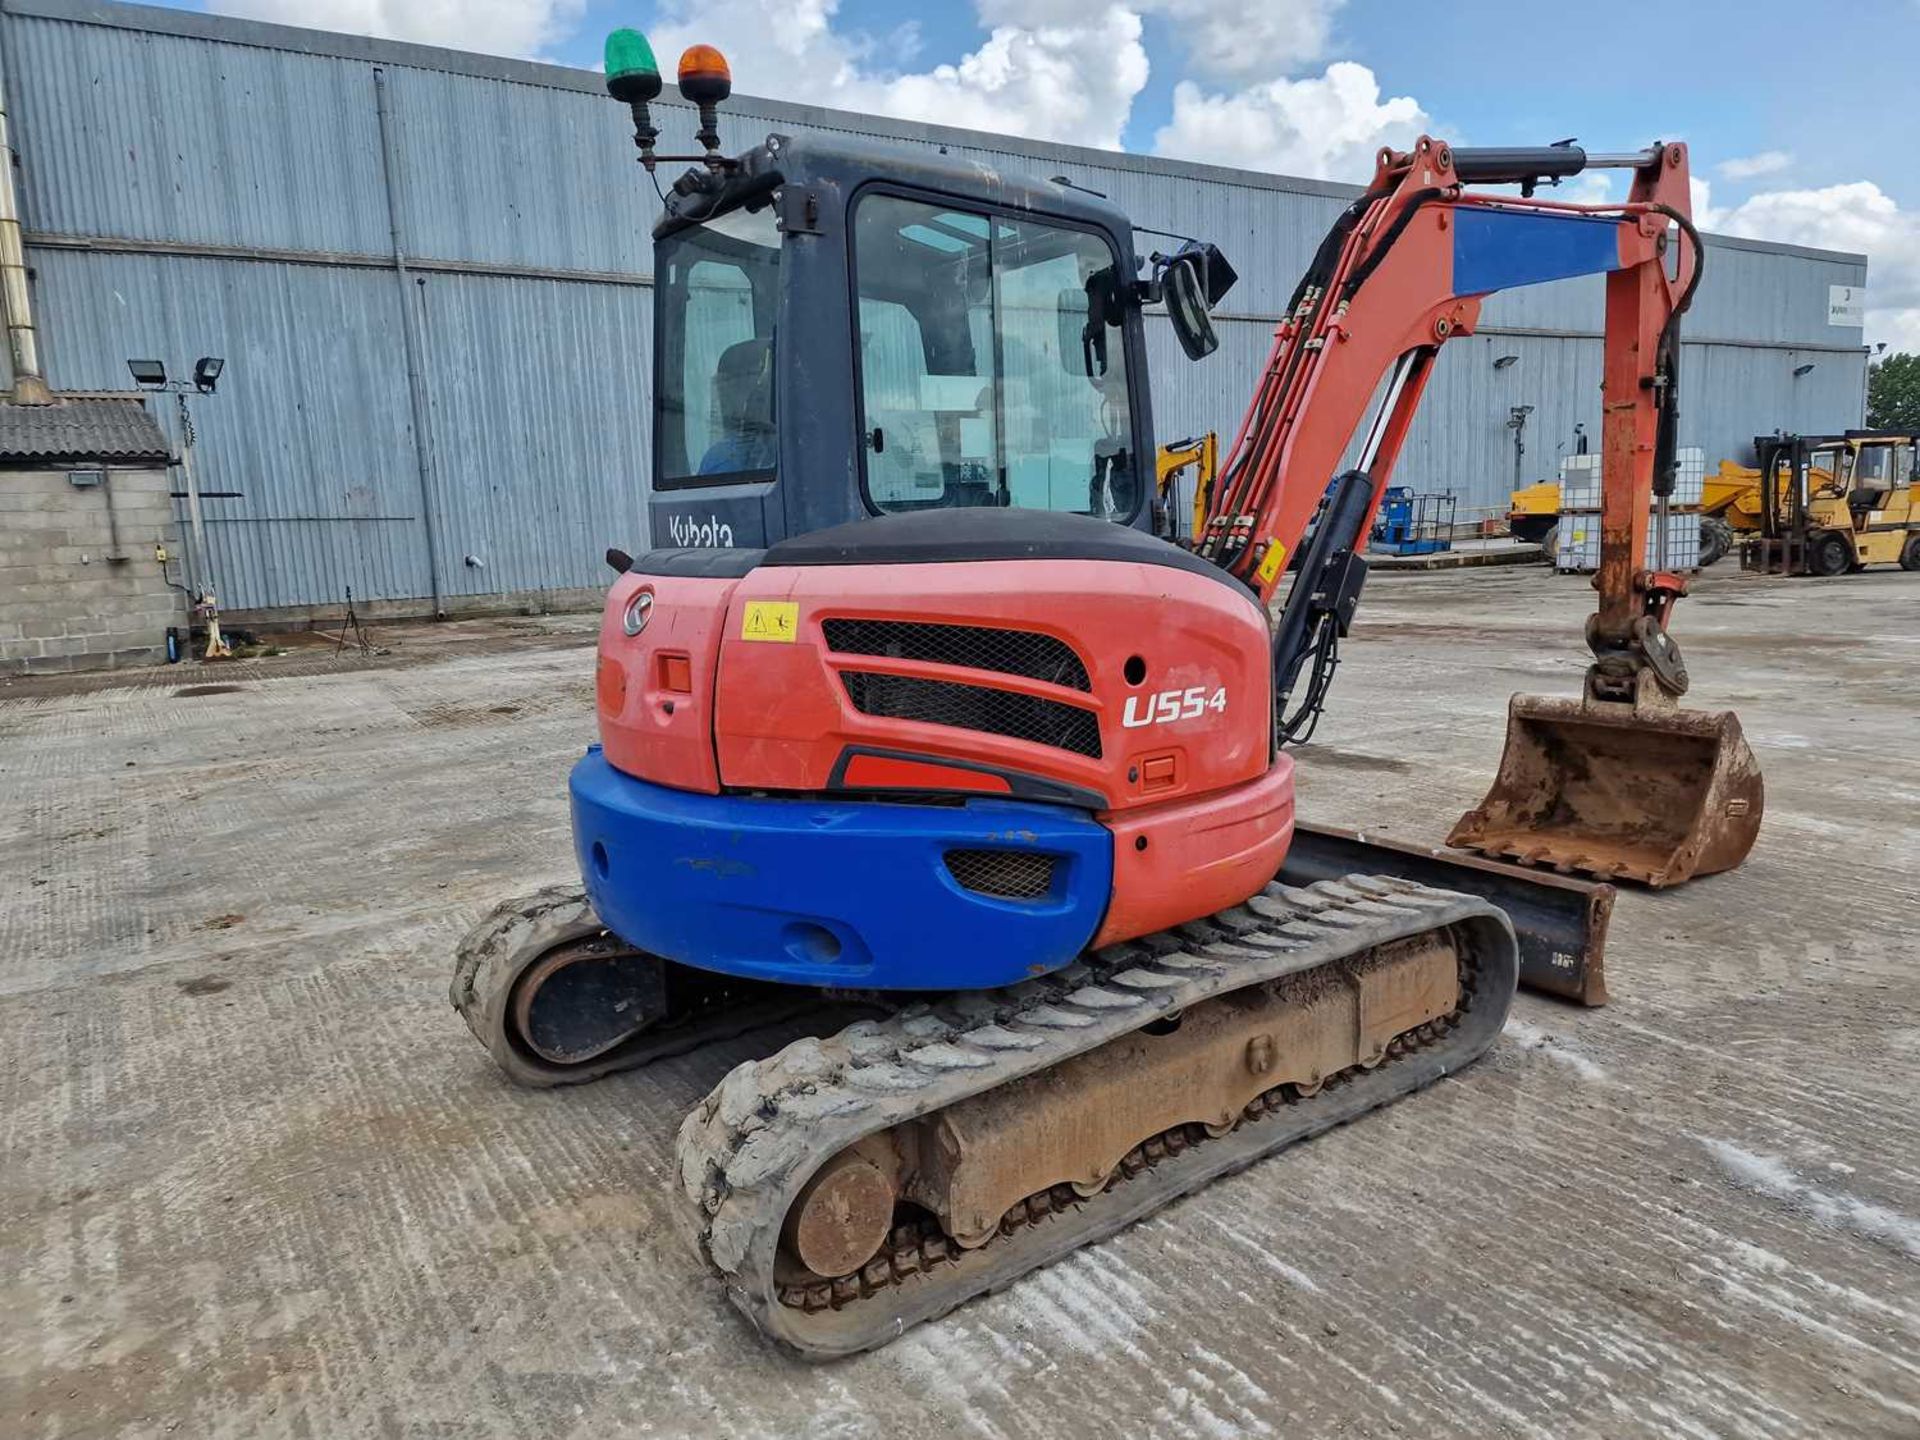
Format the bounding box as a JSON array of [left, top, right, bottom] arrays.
[[653, 207, 780, 488]]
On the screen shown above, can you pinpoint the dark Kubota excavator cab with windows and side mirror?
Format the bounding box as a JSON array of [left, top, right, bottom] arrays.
[[649, 134, 1233, 547]]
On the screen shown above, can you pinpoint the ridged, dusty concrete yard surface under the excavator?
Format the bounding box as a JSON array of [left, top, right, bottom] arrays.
[[0, 564, 1920, 1440]]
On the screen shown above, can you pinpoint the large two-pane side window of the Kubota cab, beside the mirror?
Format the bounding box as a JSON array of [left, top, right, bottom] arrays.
[[854, 196, 1140, 518]]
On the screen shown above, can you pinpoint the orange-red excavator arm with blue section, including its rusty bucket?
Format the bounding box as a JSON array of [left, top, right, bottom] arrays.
[[1196, 138, 1763, 885]]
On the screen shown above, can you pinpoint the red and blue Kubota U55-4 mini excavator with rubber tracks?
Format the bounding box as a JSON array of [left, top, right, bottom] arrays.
[[453, 31, 1761, 1357]]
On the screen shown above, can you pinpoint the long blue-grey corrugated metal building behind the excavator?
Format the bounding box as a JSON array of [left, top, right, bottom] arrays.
[[0, 0, 1866, 611]]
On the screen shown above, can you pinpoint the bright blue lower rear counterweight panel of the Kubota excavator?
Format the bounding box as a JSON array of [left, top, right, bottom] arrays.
[[570, 745, 1114, 991]]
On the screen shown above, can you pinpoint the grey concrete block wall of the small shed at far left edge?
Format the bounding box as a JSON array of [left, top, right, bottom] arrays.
[[0, 468, 186, 674]]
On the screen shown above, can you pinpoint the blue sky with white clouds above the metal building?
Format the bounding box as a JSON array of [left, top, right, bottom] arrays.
[[175, 0, 1920, 351]]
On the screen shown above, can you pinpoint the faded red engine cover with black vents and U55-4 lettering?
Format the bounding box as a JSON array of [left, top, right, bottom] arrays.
[[599, 516, 1292, 960]]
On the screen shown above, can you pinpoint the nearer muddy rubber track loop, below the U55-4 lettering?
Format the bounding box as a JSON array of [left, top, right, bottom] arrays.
[[676, 876, 1519, 1359]]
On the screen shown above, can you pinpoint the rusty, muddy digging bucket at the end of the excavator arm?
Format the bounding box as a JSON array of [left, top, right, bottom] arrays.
[[1446, 695, 1764, 889]]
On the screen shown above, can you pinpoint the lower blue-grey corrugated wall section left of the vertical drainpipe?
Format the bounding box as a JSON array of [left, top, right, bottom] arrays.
[[35, 250, 430, 609]]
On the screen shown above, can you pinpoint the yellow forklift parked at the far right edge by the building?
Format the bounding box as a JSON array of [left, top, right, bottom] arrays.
[[1740, 430, 1920, 576]]
